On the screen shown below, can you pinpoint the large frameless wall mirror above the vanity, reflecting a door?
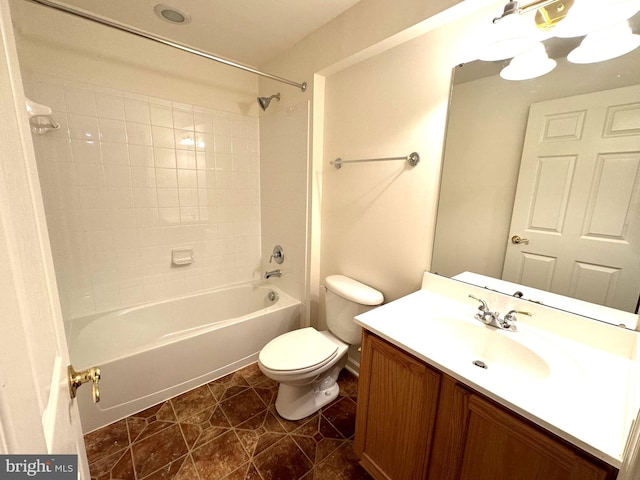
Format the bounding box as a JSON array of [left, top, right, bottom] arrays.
[[431, 13, 640, 326]]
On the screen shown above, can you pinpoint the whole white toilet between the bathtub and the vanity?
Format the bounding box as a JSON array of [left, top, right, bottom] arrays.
[[258, 275, 384, 420]]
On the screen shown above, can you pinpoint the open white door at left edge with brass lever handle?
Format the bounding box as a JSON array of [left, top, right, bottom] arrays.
[[0, 0, 91, 472]]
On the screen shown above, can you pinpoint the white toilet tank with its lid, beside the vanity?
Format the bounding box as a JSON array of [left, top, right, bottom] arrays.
[[324, 275, 384, 345]]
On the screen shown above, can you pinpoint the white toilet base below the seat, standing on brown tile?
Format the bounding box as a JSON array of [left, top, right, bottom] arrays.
[[276, 362, 345, 420]]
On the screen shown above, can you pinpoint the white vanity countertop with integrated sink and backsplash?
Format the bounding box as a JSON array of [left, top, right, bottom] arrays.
[[356, 275, 640, 468]]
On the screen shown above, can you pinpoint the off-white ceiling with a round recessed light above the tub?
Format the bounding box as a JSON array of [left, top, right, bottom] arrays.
[[51, 0, 359, 67]]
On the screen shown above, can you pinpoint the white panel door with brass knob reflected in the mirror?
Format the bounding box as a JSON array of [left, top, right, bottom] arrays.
[[502, 86, 640, 312]]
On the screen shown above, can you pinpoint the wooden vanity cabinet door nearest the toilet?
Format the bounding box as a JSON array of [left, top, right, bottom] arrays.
[[354, 332, 441, 480]]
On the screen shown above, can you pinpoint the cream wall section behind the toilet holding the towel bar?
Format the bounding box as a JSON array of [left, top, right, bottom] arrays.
[[321, 31, 450, 301]]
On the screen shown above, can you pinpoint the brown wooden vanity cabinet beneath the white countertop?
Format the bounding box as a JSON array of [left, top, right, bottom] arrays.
[[354, 330, 618, 480]]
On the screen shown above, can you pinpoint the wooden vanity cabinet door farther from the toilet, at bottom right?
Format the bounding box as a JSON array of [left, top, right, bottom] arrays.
[[459, 395, 615, 480]]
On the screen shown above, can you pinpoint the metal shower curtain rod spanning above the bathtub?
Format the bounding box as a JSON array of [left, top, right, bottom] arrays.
[[26, 0, 307, 92]]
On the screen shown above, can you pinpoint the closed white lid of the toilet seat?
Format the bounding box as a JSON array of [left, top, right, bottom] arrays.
[[260, 327, 338, 371]]
